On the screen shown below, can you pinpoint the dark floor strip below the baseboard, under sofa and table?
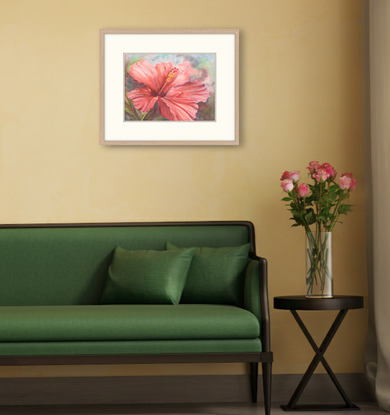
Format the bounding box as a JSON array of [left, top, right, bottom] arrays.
[[0, 402, 388, 415]]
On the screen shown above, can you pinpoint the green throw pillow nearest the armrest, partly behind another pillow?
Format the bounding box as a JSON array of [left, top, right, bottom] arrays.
[[165, 242, 250, 306]]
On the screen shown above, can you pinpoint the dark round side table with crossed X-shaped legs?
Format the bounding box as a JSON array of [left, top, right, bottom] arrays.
[[274, 295, 364, 411]]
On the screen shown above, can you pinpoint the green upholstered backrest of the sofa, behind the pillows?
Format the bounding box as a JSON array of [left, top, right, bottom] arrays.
[[0, 222, 254, 306]]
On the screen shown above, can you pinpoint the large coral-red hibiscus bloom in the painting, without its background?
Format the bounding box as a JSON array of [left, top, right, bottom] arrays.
[[127, 60, 210, 121]]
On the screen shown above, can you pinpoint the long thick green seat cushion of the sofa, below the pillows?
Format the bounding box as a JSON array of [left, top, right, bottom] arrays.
[[0, 304, 260, 342]]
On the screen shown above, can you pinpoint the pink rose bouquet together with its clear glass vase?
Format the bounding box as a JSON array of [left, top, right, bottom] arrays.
[[280, 161, 358, 297]]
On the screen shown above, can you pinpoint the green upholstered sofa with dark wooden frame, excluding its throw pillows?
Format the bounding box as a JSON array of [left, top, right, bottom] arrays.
[[0, 222, 272, 414]]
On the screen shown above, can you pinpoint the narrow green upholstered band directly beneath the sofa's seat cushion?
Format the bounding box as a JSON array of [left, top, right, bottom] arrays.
[[0, 339, 261, 356]]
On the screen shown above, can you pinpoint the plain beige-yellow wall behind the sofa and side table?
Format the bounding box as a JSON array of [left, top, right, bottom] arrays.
[[0, 0, 367, 377]]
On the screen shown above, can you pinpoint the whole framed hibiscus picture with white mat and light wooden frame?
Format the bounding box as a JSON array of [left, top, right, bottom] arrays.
[[100, 29, 239, 145]]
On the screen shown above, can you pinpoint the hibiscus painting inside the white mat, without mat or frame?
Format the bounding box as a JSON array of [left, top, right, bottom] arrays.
[[124, 53, 215, 121]]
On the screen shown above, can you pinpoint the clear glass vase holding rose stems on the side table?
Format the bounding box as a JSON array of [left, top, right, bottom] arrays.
[[306, 231, 333, 298]]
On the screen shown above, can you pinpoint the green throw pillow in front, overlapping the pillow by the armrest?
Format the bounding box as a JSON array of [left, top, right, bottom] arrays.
[[100, 246, 195, 304]]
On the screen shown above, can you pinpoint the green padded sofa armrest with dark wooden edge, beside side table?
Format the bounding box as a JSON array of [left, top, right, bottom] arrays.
[[243, 255, 271, 352]]
